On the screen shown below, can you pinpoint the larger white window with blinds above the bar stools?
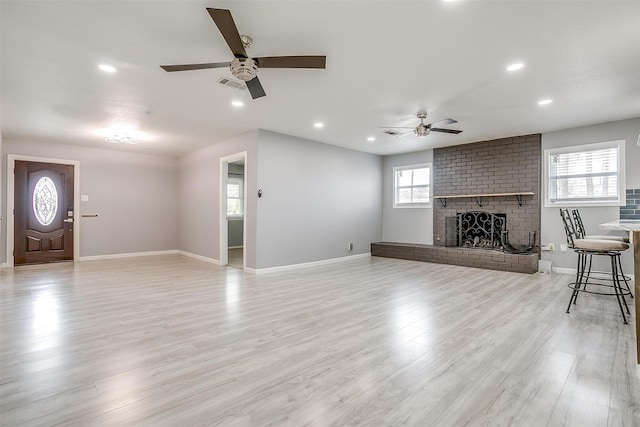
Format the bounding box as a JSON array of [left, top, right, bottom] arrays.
[[544, 141, 625, 207]]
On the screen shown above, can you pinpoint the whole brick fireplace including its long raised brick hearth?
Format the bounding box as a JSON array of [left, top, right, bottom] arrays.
[[371, 134, 541, 273]]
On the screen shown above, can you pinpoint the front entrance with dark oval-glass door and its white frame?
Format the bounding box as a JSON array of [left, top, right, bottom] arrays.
[[7, 154, 79, 266]]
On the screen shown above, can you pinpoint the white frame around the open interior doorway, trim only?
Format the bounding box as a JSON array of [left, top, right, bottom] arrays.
[[219, 151, 247, 270]]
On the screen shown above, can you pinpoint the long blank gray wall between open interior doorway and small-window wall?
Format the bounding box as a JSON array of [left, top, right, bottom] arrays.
[[256, 130, 382, 268]]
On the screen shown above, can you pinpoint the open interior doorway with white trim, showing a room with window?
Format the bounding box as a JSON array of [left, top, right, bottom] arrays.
[[220, 152, 246, 270]]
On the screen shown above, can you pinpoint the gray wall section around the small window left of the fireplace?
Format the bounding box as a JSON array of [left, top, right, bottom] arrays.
[[382, 150, 433, 245]]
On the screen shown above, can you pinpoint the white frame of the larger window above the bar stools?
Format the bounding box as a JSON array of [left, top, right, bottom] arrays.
[[542, 140, 626, 208]]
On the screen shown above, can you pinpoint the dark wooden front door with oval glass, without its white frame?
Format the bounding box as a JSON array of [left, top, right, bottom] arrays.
[[14, 161, 74, 265]]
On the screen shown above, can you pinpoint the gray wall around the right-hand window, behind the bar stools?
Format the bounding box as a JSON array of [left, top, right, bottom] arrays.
[[541, 118, 640, 273]]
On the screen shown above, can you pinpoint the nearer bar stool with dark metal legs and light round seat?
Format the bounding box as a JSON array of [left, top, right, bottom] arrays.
[[560, 209, 630, 324]]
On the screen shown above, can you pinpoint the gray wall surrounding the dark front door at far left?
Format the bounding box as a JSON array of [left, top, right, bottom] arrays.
[[2, 140, 178, 262]]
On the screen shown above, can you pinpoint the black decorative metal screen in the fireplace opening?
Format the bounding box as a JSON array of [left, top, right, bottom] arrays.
[[456, 212, 507, 249]]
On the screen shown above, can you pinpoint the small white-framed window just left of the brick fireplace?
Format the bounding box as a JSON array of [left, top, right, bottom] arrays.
[[393, 163, 431, 208]]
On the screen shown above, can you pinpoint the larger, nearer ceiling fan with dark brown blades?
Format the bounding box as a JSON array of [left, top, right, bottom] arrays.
[[160, 7, 327, 99]]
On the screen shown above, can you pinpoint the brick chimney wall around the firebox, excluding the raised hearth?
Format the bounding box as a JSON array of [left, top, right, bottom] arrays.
[[433, 134, 541, 252]]
